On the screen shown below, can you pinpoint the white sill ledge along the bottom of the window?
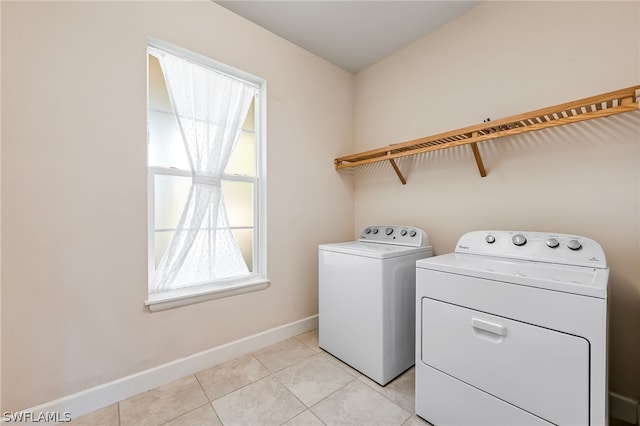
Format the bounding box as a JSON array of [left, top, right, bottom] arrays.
[[144, 277, 271, 312]]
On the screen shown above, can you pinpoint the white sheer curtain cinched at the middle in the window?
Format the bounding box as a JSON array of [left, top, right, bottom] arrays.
[[149, 49, 256, 293]]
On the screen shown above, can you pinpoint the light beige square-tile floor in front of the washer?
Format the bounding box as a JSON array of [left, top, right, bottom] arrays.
[[71, 330, 429, 426]]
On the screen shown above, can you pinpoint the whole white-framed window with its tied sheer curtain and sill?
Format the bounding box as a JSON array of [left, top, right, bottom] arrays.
[[146, 42, 268, 311]]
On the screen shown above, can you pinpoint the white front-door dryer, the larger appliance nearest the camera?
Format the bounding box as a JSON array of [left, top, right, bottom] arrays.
[[416, 231, 609, 426]]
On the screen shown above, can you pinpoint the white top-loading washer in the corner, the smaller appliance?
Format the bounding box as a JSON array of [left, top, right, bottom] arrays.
[[318, 225, 432, 385]]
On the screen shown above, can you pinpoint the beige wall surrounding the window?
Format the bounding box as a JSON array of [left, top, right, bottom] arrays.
[[1, 2, 354, 411]]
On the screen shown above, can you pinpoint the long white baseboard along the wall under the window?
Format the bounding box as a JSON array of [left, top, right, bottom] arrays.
[[16, 315, 318, 426]]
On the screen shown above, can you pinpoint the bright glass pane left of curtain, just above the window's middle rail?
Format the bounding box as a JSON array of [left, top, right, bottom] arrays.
[[148, 110, 190, 170]]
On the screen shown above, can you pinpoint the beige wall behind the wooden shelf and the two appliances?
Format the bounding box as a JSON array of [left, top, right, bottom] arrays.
[[356, 2, 640, 398]]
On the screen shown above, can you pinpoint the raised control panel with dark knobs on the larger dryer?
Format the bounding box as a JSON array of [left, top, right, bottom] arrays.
[[455, 231, 607, 268]]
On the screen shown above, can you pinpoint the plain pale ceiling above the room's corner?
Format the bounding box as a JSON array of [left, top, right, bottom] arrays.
[[215, 0, 481, 74]]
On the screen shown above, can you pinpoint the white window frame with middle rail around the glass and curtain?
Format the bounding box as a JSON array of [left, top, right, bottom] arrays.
[[145, 37, 270, 312]]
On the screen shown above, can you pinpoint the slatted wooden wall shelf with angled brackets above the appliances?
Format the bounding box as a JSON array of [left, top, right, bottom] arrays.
[[334, 85, 640, 184]]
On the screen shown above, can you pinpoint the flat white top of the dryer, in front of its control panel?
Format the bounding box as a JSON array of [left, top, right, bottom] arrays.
[[416, 253, 609, 299]]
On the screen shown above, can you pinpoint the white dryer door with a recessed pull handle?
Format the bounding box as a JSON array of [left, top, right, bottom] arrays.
[[420, 298, 589, 425]]
